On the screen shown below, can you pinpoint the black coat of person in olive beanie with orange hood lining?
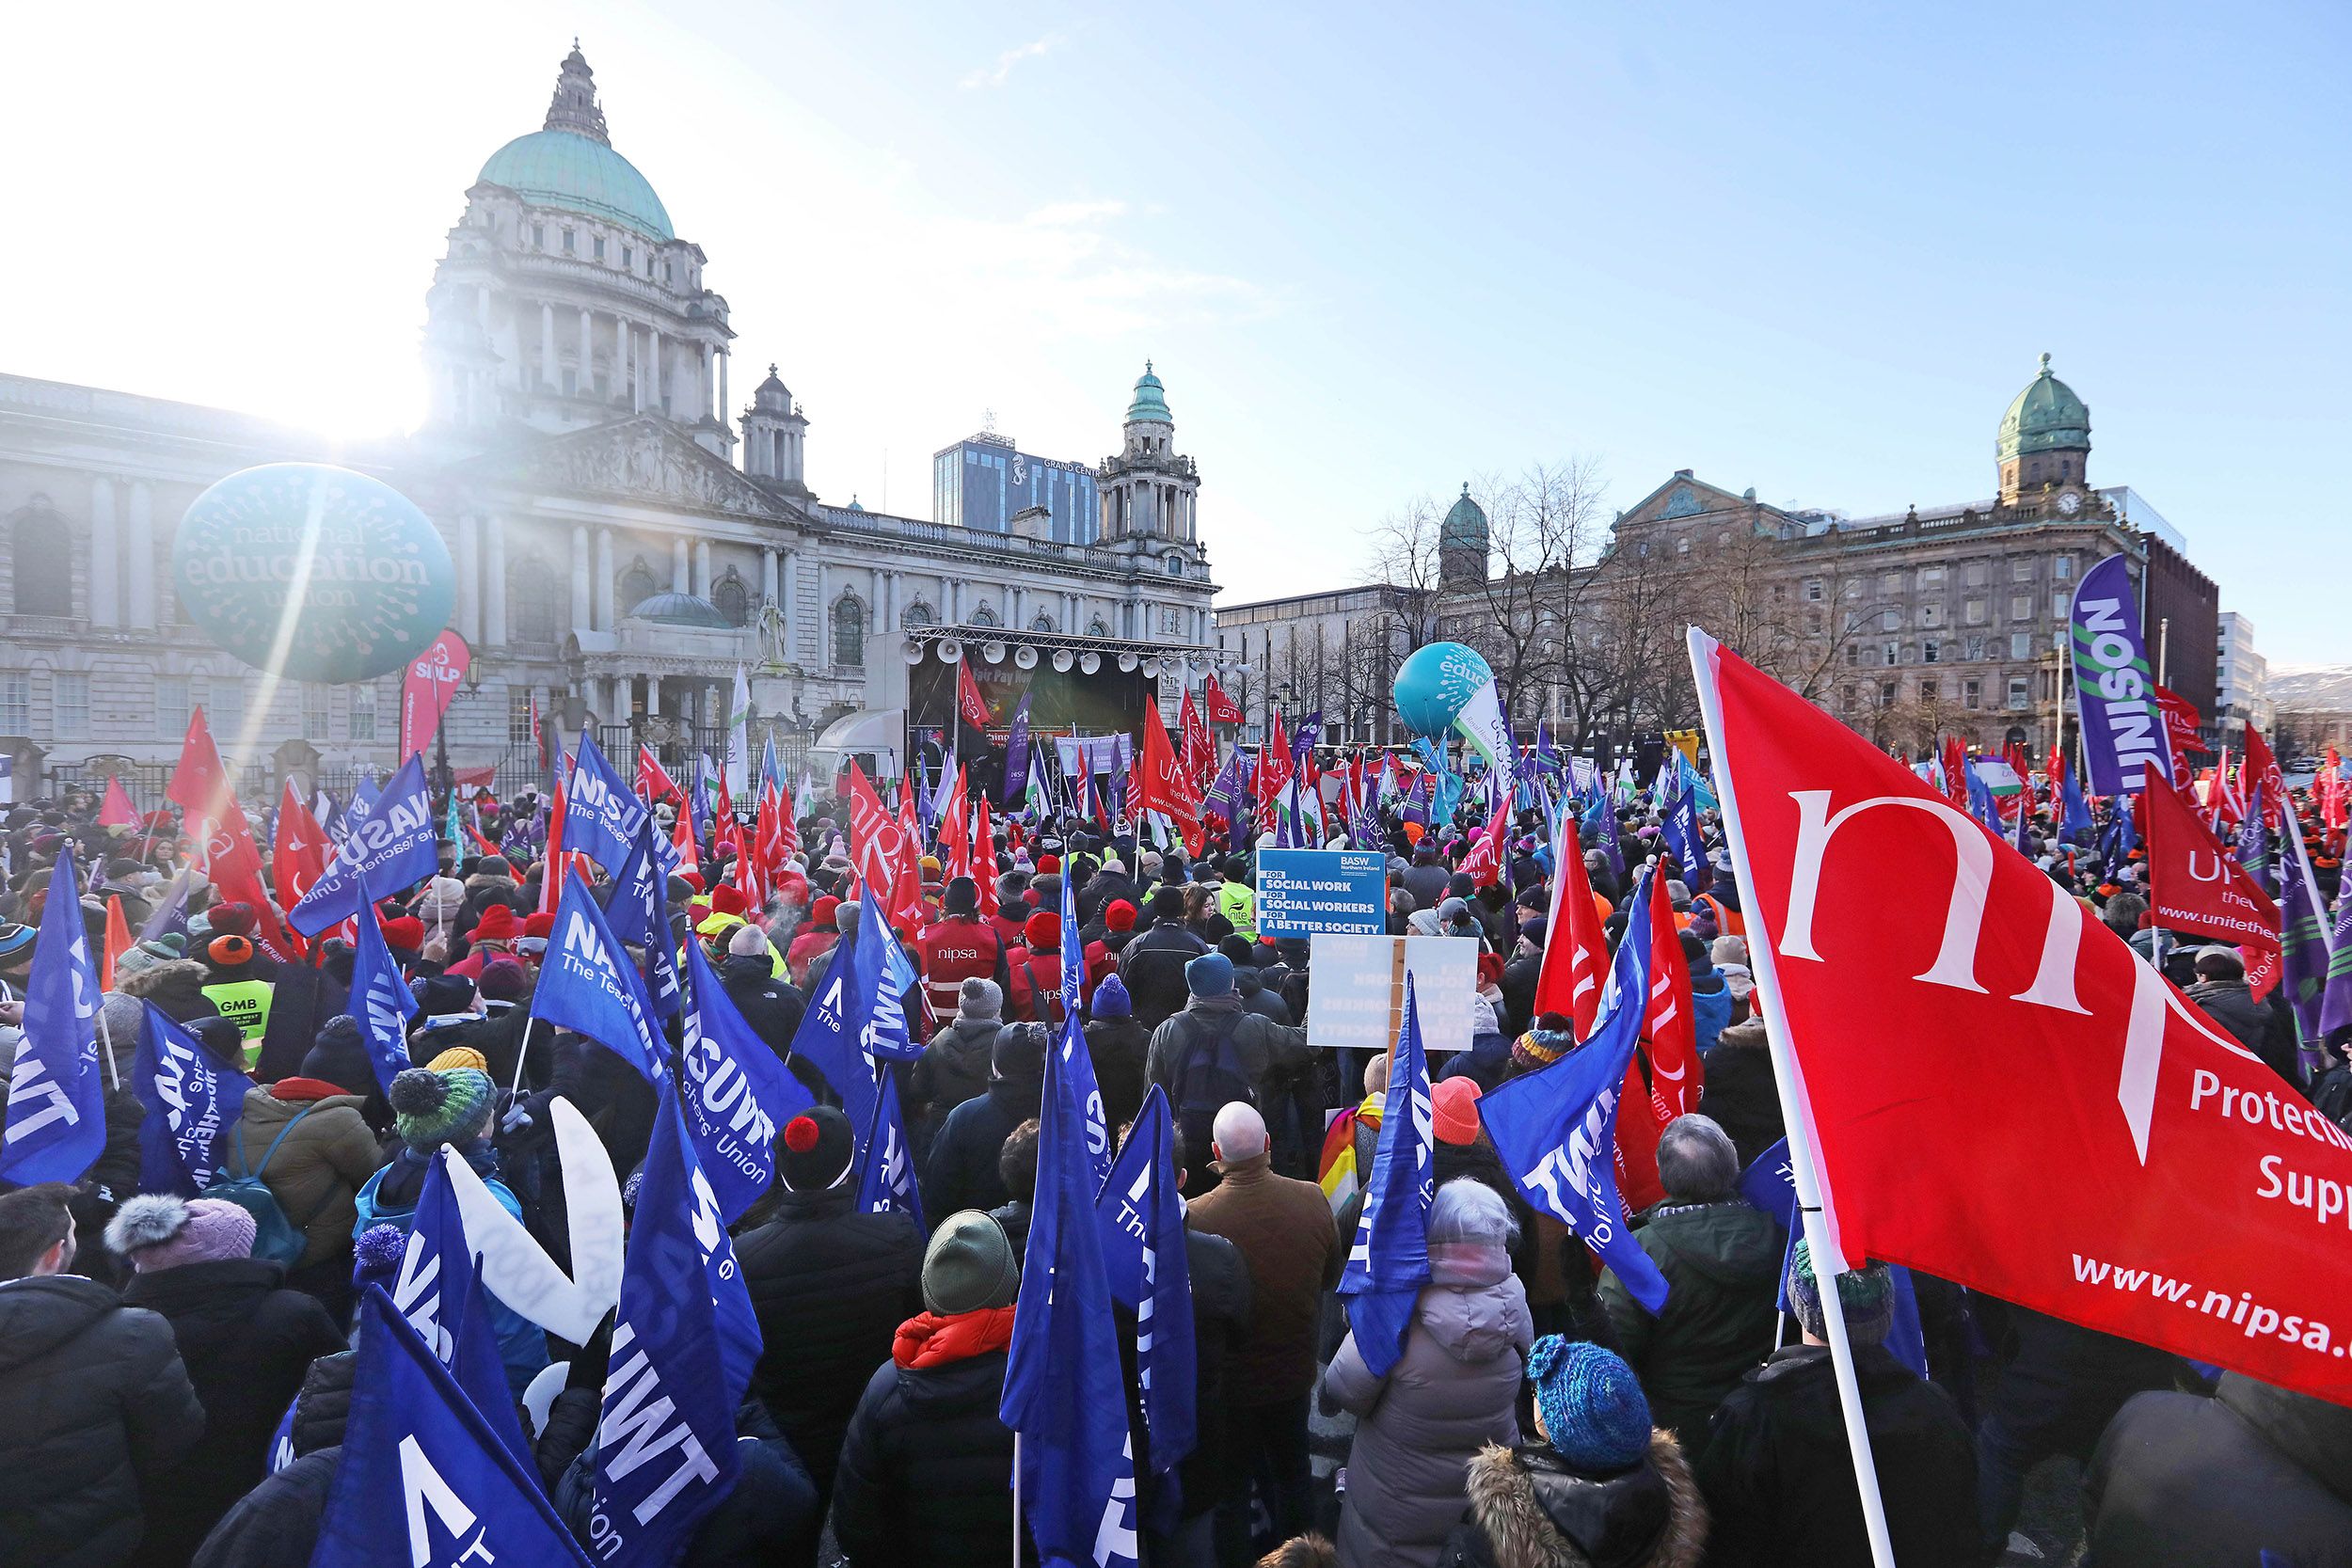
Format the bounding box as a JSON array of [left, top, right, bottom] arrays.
[[833, 1350, 1038, 1568]]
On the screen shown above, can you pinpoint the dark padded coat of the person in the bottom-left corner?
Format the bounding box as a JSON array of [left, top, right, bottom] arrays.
[[0, 1275, 205, 1568]]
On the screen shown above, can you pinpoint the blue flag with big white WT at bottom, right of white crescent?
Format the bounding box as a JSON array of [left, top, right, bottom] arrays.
[[596, 1074, 760, 1568]]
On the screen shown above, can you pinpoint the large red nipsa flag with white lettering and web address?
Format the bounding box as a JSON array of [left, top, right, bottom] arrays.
[[1692, 632, 2352, 1403]]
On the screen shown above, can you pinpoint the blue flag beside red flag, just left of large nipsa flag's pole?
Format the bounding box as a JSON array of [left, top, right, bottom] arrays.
[[1486, 877, 1665, 1314]]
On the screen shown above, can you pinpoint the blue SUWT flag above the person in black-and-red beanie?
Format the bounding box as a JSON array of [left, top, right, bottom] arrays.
[[680, 942, 817, 1225]]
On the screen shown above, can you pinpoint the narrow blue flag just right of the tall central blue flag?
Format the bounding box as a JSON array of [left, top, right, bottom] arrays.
[[1094, 1084, 1198, 1474]]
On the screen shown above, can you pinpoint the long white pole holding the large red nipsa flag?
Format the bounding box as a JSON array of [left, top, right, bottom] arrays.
[[1689, 626, 1896, 1568]]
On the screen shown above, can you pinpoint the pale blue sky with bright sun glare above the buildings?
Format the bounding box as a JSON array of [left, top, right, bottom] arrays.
[[0, 0, 2352, 663]]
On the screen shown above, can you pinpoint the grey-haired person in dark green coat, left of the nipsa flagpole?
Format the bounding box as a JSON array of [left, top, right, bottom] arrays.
[[1597, 1115, 1786, 1465]]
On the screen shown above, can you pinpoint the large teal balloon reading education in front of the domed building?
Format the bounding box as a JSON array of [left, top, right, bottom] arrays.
[[172, 463, 456, 682]]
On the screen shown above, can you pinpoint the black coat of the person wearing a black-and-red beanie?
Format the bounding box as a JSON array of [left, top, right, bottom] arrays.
[[737, 1185, 925, 1497]]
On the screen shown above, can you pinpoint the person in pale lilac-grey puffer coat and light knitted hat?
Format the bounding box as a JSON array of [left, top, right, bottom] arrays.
[[1320, 1180, 1536, 1568]]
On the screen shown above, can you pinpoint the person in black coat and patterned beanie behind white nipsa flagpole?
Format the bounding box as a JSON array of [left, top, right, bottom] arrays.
[[1693, 1239, 1976, 1568]]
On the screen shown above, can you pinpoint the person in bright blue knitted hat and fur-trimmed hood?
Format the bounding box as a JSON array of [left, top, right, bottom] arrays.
[[1442, 1336, 1708, 1568]]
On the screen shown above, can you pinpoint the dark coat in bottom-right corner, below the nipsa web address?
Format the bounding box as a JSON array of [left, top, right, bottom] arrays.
[[2082, 1373, 2352, 1568]]
